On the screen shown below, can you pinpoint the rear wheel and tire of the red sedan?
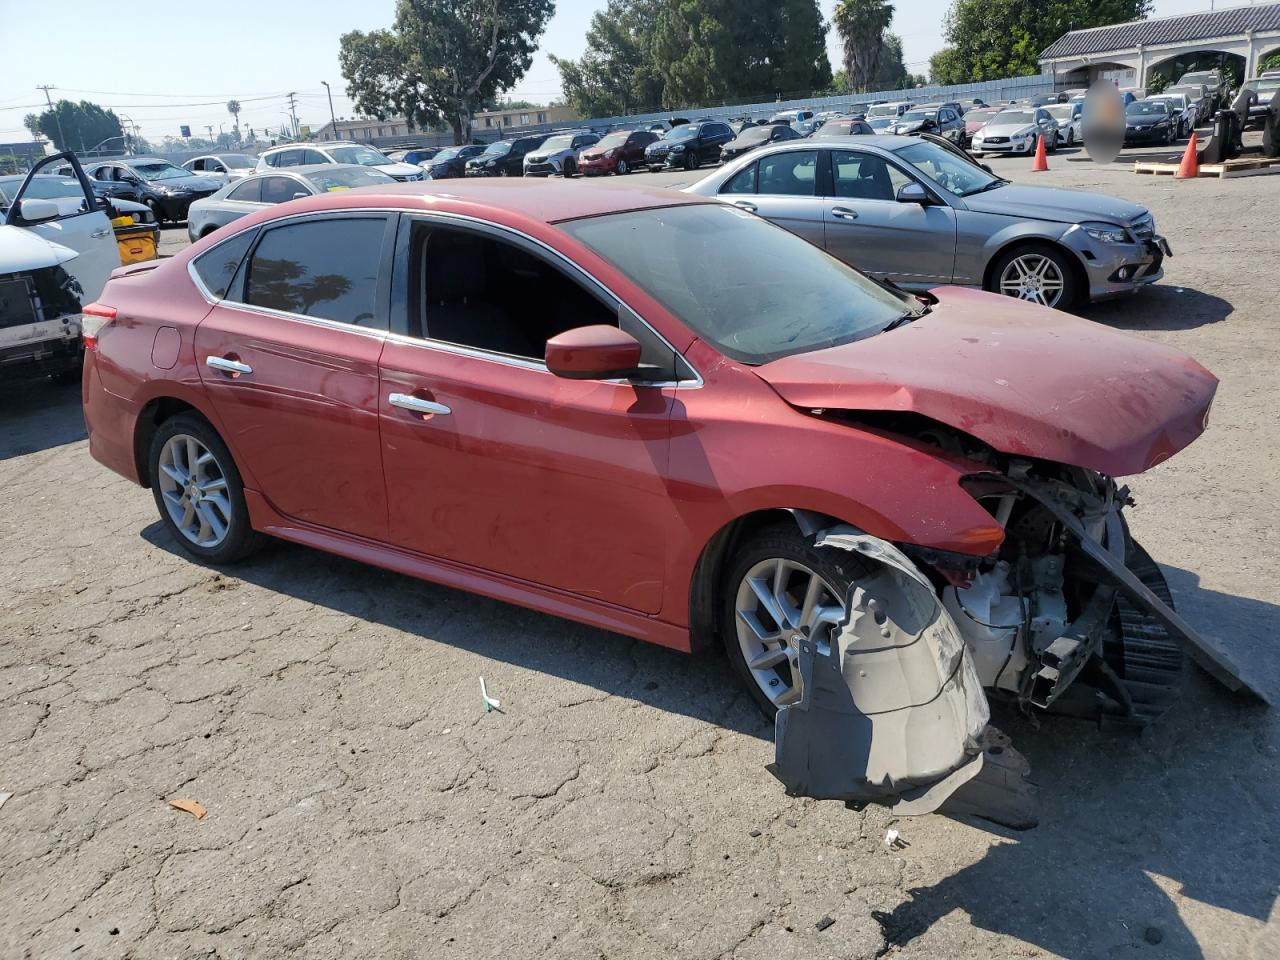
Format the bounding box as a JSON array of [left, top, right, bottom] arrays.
[[147, 413, 259, 563]]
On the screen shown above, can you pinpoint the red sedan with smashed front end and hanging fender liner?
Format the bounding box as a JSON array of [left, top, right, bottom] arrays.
[[83, 180, 1259, 819]]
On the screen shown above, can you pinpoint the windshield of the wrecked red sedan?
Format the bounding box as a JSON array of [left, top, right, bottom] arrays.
[[561, 204, 924, 364]]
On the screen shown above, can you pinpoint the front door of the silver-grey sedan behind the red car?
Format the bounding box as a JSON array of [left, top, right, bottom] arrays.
[[824, 150, 956, 289]]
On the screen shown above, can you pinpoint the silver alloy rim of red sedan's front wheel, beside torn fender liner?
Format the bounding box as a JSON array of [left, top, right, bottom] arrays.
[[733, 557, 845, 707]]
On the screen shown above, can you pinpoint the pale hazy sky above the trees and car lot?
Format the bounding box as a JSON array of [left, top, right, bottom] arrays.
[[0, 0, 1233, 142]]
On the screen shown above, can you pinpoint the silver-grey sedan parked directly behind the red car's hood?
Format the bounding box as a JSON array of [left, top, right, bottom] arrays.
[[686, 136, 1170, 308]]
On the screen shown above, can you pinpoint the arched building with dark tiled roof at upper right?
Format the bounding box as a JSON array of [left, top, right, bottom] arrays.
[[1039, 3, 1280, 87]]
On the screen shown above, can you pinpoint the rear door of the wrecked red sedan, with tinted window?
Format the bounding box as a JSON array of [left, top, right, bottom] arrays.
[[195, 214, 394, 540]]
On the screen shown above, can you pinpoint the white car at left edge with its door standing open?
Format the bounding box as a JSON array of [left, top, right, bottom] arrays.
[[0, 154, 120, 379]]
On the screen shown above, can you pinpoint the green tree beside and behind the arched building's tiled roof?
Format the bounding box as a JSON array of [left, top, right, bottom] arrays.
[[929, 0, 1152, 83]]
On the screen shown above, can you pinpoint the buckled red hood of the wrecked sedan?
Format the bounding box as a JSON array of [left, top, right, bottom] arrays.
[[755, 287, 1217, 476]]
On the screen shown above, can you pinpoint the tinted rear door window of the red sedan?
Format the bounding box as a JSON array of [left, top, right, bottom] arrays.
[[244, 216, 387, 329]]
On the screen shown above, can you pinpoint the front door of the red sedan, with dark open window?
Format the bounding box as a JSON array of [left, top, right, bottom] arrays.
[[379, 220, 673, 613]]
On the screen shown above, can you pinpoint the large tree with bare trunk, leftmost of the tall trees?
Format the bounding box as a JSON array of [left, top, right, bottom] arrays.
[[338, 0, 556, 143]]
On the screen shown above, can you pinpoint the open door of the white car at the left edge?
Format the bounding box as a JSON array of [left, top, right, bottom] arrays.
[[5, 154, 120, 305]]
